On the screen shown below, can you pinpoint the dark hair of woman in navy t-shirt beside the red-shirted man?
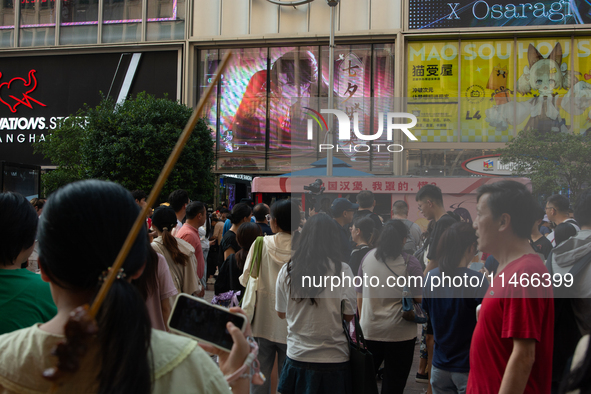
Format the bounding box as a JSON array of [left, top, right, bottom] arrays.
[[433, 222, 478, 274]]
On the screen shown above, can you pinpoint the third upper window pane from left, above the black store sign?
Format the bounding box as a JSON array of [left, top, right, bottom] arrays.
[[60, 0, 98, 45]]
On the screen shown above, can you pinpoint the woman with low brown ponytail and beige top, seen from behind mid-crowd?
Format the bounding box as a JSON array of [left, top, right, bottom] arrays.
[[152, 205, 205, 302]]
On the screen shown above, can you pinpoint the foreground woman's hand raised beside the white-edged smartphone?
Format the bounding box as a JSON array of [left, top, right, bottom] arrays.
[[199, 307, 252, 375]]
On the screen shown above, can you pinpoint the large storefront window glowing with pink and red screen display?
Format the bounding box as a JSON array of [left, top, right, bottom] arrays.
[[199, 44, 394, 173]]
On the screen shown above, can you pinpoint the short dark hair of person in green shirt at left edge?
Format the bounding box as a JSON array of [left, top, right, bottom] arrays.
[[0, 192, 39, 266]]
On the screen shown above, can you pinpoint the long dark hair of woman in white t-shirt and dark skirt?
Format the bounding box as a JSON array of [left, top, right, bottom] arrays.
[[286, 213, 343, 305]]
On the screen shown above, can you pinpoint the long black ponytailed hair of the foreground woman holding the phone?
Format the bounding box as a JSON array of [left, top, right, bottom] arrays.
[[38, 180, 152, 394]]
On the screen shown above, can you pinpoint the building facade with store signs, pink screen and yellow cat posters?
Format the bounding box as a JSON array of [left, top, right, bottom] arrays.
[[0, 0, 591, 197]]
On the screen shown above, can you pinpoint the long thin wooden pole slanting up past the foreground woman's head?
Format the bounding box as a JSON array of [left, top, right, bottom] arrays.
[[88, 51, 232, 319]]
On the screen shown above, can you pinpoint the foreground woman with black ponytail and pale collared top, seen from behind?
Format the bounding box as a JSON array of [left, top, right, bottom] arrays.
[[0, 180, 250, 394]]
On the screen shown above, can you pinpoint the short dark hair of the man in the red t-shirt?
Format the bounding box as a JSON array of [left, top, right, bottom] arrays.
[[476, 180, 537, 239]]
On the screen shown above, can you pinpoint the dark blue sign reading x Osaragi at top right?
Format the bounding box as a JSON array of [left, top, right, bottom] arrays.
[[409, 0, 591, 29]]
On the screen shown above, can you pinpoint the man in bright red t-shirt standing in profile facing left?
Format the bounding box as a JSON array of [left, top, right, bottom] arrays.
[[466, 181, 554, 394]]
